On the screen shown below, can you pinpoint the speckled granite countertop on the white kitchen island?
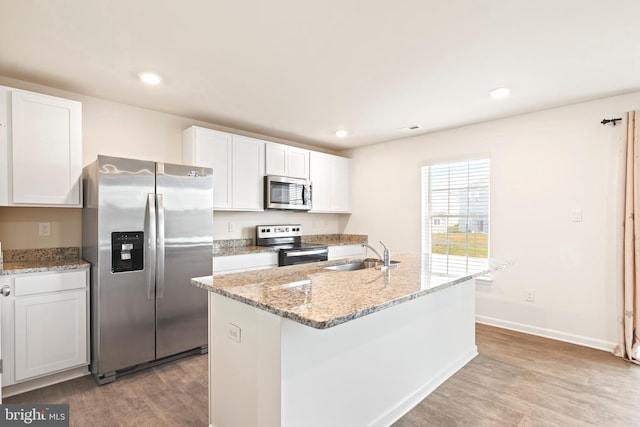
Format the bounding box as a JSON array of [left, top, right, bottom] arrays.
[[192, 253, 500, 329]]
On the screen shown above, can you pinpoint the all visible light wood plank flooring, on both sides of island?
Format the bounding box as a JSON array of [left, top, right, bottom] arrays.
[[5, 325, 640, 427]]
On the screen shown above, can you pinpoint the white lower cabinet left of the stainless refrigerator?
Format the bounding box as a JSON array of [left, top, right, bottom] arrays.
[[2, 269, 89, 392]]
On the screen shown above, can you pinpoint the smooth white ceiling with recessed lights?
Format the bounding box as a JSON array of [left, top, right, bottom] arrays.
[[0, 0, 640, 149]]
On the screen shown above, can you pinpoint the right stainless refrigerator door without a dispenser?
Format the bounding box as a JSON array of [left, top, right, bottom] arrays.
[[156, 163, 213, 358]]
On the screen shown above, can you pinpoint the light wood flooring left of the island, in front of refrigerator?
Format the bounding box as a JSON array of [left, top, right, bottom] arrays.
[[3, 355, 209, 427]]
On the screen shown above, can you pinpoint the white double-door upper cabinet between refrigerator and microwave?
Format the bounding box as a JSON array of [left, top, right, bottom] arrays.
[[182, 126, 265, 211]]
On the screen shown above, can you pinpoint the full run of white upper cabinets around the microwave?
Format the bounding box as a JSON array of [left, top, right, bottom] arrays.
[[182, 126, 351, 213]]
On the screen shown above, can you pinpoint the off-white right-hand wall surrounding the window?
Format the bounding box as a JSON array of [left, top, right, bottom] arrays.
[[345, 93, 640, 349]]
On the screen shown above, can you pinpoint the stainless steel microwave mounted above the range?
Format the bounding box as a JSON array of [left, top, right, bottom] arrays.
[[264, 175, 311, 211]]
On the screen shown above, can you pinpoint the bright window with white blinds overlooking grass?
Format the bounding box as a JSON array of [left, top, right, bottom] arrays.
[[422, 159, 489, 275]]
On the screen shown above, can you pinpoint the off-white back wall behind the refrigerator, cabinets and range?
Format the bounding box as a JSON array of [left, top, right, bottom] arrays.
[[0, 76, 344, 249]]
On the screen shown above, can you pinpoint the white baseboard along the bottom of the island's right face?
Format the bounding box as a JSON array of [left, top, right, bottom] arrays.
[[371, 345, 478, 426]]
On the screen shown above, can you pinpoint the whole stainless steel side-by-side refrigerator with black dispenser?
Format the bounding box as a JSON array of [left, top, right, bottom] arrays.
[[82, 156, 213, 384]]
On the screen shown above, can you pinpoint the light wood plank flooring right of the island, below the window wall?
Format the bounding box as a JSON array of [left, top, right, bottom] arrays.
[[394, 325, 640, 427]]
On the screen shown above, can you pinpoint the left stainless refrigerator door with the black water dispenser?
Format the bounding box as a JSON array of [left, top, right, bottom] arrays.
[[94, 156, 155, 376]]
